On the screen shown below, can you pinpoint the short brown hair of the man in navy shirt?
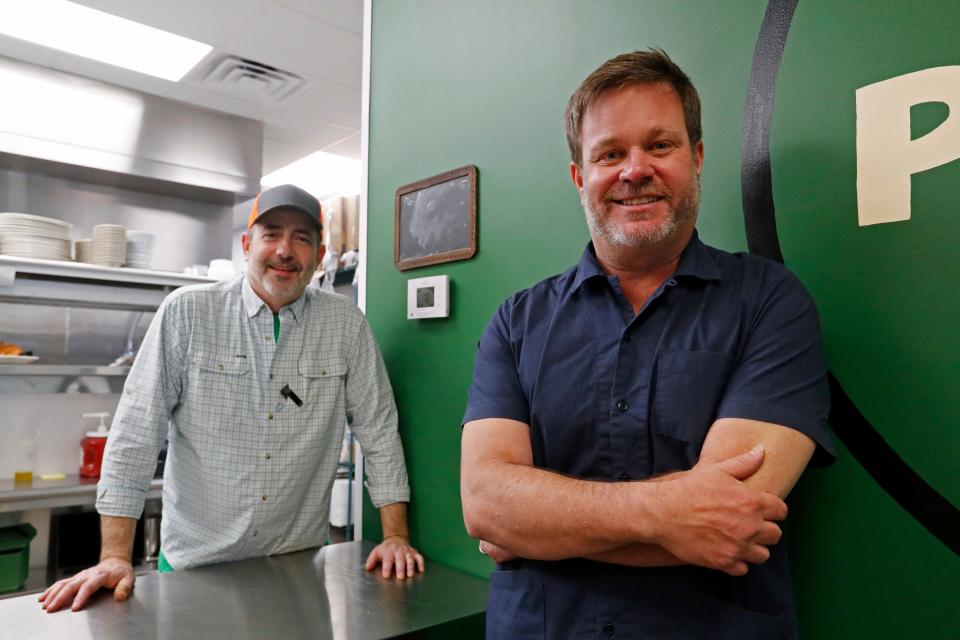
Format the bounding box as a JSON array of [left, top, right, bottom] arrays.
[[563, 48, 703, 167]]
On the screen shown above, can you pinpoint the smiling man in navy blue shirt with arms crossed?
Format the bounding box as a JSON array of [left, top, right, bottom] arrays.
[[461, 50, 833, 640]]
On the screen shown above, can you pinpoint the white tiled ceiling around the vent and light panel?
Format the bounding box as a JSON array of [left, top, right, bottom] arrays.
[[0, 0, 363, 174]]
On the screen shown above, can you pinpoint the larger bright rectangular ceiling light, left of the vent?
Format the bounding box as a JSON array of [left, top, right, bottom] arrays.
[[0, 0, 213, 82]]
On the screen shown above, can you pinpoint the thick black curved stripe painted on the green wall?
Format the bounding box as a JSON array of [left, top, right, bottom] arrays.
[[740, 0, 960, 554]]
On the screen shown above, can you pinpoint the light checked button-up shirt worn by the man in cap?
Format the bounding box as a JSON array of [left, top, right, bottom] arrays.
[[97, 276, 410, 569]]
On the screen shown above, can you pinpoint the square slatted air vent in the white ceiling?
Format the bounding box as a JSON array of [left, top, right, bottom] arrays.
[[190, 55, 309, 104]]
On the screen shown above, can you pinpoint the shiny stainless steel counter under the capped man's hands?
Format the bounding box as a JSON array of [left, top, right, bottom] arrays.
[[0, 541, 487, 640]]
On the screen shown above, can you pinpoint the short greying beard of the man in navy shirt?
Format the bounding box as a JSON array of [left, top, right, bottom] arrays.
[[580, 174, 700, 247]]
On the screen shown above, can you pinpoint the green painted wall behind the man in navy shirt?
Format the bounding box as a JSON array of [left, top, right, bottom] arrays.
[[364, 0, 960, 638]]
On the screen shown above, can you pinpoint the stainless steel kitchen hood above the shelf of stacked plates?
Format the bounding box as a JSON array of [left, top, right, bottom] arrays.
[[0, 57, 263, 195]]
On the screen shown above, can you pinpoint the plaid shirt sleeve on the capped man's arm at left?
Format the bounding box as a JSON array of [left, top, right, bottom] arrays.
[[96, 294, 189, 518]]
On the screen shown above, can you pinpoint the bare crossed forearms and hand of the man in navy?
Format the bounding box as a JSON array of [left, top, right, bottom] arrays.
[[460, 418, 815, 576]]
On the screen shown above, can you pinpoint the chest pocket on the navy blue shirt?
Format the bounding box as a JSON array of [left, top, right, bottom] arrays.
[[653, 351, 732, 451]]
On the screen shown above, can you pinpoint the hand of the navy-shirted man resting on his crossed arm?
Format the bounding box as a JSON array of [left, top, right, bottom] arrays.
[[652, 446, 787, 576]]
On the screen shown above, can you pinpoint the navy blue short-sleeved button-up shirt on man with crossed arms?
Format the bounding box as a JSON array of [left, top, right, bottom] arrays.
[[464, 234, 834, 639]]
